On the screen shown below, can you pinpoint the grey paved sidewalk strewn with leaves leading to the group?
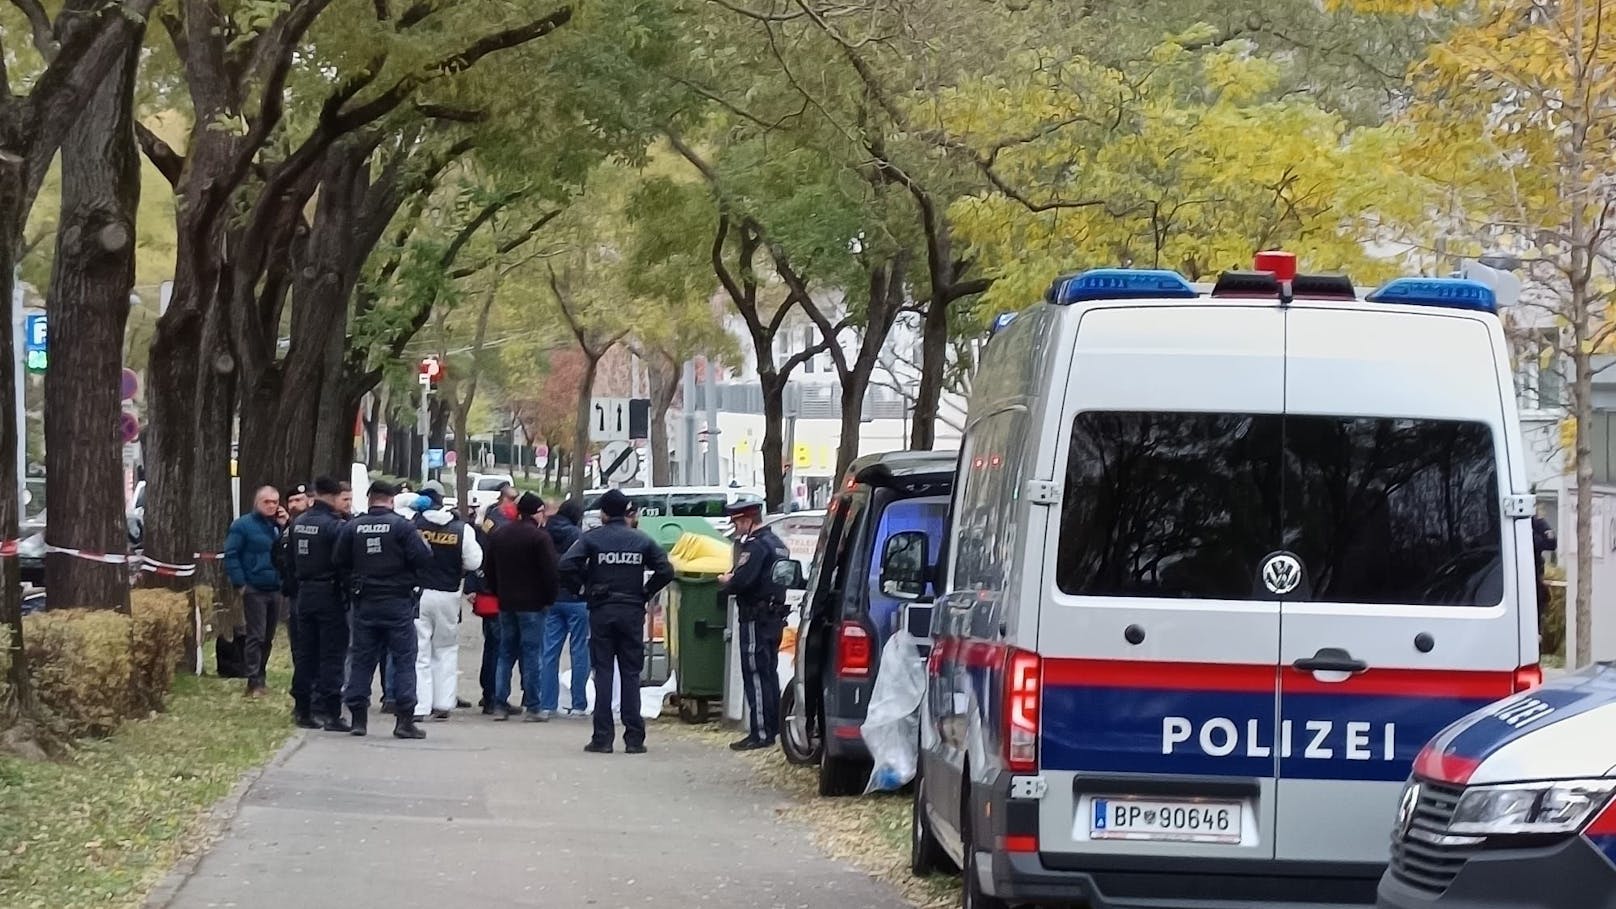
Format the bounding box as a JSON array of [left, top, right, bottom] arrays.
[[155, 623, 903, 909]]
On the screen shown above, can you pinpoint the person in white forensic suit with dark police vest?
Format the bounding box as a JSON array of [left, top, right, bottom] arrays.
[[414, 484, 483, 721]]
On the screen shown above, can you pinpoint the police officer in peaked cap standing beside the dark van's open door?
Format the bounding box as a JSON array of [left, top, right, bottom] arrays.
[[718, 500, 790, 750]]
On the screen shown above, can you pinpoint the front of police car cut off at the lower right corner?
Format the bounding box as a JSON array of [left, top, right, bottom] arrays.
[[1380, 665, 1616, 909]]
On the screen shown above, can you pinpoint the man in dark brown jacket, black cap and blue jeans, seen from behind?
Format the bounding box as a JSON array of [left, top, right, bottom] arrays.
[[483, 493, 556, 723]]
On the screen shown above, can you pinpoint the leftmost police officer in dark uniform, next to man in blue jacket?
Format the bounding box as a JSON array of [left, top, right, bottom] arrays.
[[288, 477, 354, 733]]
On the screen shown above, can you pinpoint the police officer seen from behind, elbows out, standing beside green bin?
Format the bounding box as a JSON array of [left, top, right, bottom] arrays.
[[561, 490, 674, 754]]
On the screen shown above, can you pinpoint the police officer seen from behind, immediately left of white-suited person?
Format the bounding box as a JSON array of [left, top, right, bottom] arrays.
[[335, 480, 433, 739]]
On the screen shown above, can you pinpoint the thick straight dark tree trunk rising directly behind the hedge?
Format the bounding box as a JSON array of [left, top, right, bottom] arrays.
[[45, 31, 141, 611]]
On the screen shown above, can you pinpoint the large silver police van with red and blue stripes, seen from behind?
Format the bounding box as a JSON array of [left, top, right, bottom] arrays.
[[913, 254, 1540, 909]]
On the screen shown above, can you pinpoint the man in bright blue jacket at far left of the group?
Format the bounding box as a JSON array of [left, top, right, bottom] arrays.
[[225, 487, 286, 697]]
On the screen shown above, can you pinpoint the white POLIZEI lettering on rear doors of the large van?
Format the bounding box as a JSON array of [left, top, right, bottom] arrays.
[[1162, 717, 1398, 760]]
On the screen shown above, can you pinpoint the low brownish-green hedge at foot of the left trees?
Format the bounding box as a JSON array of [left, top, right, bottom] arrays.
[[0, 590, 191, 738]]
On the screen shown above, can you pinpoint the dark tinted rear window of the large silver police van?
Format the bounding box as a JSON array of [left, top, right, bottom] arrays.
[[1055, 412, 1503, 605]]
